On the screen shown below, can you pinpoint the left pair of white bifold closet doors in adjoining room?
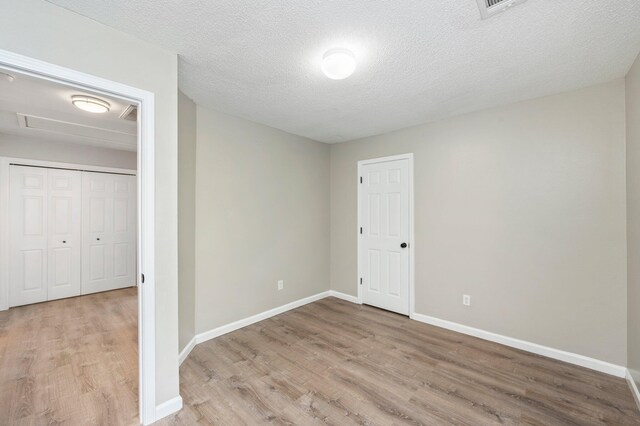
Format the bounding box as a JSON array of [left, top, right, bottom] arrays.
[[9, 166, 81, 306]]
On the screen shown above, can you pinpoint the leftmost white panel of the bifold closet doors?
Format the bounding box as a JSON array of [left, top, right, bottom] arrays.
[[9, 166, 48, 307]]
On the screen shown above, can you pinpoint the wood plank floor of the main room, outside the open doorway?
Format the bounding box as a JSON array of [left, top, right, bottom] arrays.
[[159, 298, 640, 426]]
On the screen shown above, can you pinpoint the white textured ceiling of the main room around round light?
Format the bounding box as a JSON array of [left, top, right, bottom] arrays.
[[50, 0, 640, 142]]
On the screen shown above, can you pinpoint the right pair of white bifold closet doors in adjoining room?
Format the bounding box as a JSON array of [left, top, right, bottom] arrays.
[[82, 172, 136, 294]]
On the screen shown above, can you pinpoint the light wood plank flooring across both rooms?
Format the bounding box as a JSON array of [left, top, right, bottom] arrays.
[[0, 289, 640, 426]]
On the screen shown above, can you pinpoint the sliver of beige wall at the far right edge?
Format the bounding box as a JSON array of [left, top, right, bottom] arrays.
[[626, 51, 640, 387]]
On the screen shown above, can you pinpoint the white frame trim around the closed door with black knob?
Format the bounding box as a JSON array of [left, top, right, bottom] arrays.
[[356, 153, 416, 319]]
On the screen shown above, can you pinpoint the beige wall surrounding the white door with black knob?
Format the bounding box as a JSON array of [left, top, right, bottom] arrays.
[[331, 80, 627, 365]]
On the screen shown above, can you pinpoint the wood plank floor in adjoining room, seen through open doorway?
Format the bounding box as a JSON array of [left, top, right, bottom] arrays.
[[0, 287, 139, 425]]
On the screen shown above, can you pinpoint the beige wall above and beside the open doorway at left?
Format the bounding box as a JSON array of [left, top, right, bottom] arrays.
[[0, 0, 178, 404]]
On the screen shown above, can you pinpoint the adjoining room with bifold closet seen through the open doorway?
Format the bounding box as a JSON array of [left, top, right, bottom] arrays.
[[0, 65, 138, 424]]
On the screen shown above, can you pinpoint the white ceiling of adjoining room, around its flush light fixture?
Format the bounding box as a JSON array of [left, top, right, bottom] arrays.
[[0, 68, 137, 151]]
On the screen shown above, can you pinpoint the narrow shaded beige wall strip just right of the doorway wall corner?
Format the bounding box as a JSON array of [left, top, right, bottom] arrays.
[[178, 92, 196, 351]]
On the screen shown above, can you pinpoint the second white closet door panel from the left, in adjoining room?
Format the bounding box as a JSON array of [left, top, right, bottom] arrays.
[[47, 169, 82, 300]]
